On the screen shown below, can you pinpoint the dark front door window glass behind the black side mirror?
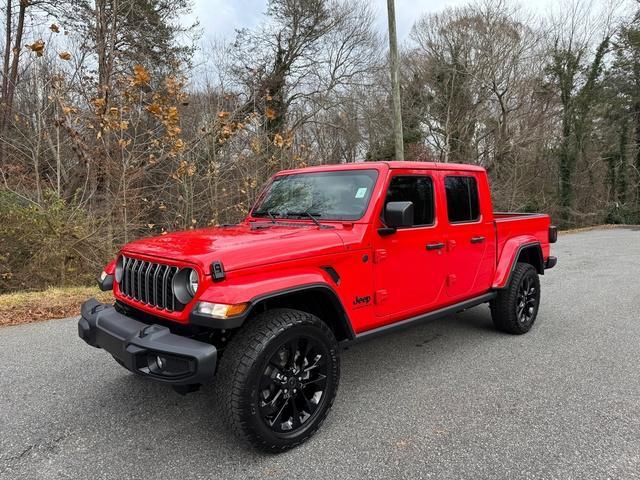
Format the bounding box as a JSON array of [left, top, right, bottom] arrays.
[[385, 175, 434, 227]]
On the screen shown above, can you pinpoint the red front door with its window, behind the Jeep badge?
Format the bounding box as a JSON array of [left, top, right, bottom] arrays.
[[374, 170, 446, 325]]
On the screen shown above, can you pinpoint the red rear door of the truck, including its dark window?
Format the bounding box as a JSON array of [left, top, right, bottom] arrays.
[[440, 171, 495, 301]]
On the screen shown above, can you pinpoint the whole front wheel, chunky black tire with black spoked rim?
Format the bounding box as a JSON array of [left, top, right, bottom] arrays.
[[217, 309, 340, 452]]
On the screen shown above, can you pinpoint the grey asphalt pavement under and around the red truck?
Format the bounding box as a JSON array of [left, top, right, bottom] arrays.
[[0, 228, 640, 480]]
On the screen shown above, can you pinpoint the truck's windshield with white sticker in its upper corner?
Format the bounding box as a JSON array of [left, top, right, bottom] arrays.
[[253, 170, 378, 220]]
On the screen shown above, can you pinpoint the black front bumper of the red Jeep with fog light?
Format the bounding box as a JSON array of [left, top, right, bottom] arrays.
[[78, 299, 218, 385]]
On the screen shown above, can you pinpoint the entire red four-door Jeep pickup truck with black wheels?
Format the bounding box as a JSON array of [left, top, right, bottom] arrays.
[[78, 162, 557, 452]]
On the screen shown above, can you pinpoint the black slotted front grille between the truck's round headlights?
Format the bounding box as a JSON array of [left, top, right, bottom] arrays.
[[120, 257, 184, 312]]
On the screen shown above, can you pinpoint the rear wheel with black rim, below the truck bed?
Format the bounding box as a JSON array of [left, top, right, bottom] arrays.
[[491, 263, 540, 335]]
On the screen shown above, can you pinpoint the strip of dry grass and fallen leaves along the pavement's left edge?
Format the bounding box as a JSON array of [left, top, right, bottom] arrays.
[[0, 287, 113, 327]]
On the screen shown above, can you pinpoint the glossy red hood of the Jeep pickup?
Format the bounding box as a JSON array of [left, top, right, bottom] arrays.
[[122, 222, 345, 272]]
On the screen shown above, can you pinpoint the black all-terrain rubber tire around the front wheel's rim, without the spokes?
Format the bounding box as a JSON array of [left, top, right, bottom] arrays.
[[216, 309, 340, 453]]
